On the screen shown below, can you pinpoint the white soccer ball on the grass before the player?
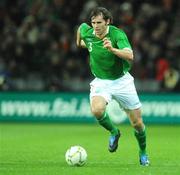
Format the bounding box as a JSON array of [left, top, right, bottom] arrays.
[[65, 146, 87, 166]]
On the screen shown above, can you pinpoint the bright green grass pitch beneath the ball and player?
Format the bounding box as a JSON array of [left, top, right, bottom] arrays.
[[0, 123, 180, 175]]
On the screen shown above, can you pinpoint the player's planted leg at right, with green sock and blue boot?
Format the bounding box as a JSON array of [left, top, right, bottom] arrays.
[[126, 108, 149, 166]]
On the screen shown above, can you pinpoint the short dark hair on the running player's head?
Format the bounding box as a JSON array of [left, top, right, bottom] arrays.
[[90, 7, 113, 23]]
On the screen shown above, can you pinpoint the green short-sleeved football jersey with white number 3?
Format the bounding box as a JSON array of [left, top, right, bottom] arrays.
[[80, 23, 131, 80]]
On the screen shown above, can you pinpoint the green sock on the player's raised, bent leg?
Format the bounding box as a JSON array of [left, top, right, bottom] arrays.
[[98, 112, 118, 135]]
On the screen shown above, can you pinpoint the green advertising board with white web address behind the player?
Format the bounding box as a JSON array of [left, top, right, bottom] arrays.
[[0, 93, 180, 123]]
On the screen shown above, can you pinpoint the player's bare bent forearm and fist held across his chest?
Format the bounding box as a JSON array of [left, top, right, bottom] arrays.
[[103, 38, 134, 61]]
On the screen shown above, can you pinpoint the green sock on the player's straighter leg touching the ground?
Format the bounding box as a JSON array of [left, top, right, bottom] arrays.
[[134, 128, 146, 154]]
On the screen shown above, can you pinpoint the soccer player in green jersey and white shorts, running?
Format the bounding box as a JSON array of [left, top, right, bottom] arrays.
[[76, 7, 149, 166]]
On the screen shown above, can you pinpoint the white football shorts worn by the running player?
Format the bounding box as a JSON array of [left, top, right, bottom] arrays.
[[90, 73, 141, 110]]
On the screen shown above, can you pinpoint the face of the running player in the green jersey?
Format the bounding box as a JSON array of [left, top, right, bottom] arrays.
[[91, 15, 109, 36]]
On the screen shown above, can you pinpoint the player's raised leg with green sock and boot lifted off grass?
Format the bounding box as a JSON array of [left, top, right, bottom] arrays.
[[91, 96, 120, 152]]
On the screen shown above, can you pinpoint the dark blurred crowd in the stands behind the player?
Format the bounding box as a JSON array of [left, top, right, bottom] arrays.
[[0, 0, 180, 92]]
